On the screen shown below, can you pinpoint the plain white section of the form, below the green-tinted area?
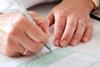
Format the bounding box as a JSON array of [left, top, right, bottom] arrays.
[[49, 53, 97, 67]]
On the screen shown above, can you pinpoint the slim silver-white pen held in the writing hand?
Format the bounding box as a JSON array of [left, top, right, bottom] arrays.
[[14, 0, 53, 52]]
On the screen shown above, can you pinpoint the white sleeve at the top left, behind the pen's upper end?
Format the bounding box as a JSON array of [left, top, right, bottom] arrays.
[[0, 0, 54, 11]]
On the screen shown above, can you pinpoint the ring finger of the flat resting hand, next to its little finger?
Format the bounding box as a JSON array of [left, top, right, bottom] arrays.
[[71, 18, 87, 46]]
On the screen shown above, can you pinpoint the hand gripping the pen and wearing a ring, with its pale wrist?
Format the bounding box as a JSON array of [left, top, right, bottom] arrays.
[[0, 12, 49, 56]]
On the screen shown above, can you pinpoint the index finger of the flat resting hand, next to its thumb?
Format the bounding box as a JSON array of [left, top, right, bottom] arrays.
[[54, 14, 66, 46]]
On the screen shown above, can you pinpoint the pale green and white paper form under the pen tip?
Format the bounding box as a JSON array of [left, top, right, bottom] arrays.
[[0, 48, 99, 67]]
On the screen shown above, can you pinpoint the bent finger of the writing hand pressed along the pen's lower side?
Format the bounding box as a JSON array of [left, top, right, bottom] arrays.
[[25, 11, 48, 42]]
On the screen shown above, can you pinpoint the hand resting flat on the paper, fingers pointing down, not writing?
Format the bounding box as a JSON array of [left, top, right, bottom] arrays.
[[47, 0, 94, 47]]
